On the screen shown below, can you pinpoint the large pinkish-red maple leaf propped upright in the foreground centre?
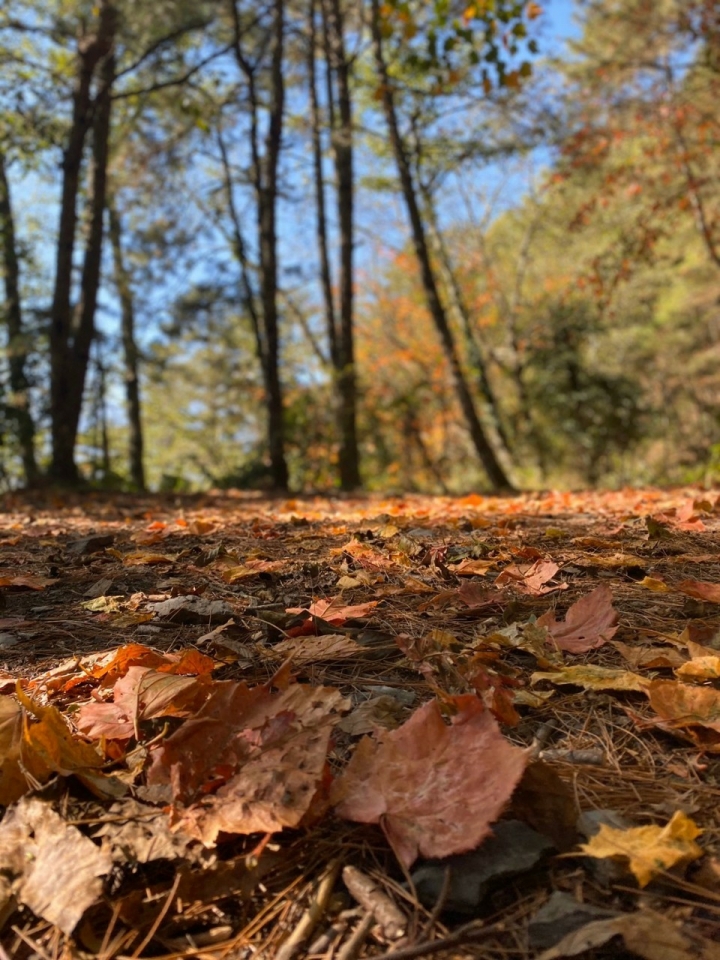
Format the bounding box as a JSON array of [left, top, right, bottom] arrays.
[[331, 694, 530, 867]]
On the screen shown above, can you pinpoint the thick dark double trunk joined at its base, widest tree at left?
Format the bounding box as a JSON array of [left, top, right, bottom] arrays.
[[50, 0, 117, 485]]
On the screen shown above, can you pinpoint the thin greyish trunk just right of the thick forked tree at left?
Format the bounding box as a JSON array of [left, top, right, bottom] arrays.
[[107, 198, 146, 493]]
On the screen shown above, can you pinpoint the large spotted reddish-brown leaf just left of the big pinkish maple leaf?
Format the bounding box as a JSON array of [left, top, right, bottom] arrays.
[[148, 678, 347, 844]]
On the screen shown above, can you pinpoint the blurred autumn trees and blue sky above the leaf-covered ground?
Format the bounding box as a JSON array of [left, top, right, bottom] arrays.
[[0, 0, 720, 492]]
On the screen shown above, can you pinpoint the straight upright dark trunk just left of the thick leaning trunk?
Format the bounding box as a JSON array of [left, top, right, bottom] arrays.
[[323, 0, 361, 490]]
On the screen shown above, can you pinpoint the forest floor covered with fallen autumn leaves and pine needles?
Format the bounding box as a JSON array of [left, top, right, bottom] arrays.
[[0, 489, 720, 960]]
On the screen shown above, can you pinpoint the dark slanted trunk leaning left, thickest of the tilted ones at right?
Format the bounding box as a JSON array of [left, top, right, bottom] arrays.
[[371, 0, 512, 491]]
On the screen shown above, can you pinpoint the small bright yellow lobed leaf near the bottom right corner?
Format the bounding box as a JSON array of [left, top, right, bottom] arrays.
[[581, 810, 703, 887]]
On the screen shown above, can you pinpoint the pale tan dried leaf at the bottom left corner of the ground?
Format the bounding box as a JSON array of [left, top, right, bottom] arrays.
[[0, 797, 112, 936]]
